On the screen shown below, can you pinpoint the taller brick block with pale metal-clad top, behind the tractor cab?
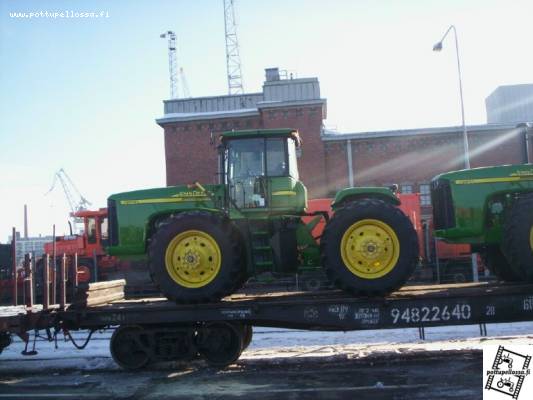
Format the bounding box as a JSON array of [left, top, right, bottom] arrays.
[[157, 68, 327, 197]]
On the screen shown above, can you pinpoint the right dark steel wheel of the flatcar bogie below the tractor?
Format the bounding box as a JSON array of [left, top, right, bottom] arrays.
[[199, 322, 244, 367]]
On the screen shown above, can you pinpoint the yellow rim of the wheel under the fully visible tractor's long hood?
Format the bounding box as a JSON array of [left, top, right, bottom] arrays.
[[165, 230, 222, 288]]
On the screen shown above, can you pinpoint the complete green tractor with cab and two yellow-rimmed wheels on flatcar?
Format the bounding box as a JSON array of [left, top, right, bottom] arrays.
[[108, 129, 418, 303]]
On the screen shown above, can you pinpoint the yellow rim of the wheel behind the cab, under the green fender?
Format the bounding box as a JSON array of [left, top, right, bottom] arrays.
[[341, 219, 400, 279]]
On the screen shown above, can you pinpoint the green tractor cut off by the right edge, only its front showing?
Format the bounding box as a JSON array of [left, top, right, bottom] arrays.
[[431, 164, 533, 282]]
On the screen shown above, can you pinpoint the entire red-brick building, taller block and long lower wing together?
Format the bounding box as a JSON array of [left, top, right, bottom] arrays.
[[157, 68, 533, 217]]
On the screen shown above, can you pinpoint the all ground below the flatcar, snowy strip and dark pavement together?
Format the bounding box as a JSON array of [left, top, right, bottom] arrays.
[[0, 323, 533, 400]]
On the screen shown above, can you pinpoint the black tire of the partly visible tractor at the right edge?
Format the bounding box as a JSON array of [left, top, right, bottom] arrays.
[[502, 194, 533, 282]]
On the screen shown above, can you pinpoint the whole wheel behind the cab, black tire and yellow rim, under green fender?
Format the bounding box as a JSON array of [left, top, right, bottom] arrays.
[[321, 199, 419, 296]]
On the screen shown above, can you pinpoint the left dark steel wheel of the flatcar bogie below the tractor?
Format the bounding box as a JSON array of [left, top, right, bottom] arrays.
[[110, 325, 150, 370]]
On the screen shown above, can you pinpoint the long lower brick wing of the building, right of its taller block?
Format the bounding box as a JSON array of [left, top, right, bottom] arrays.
[[322, 124, 533, 217]]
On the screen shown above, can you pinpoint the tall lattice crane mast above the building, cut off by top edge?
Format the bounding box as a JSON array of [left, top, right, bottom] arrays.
[[224, 0, 244, 95]]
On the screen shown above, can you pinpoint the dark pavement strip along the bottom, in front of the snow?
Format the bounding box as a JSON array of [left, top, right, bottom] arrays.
[[0, 350, 482, 400]]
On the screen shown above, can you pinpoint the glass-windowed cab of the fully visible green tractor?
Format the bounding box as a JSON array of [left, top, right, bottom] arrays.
[[220, 129, 307, 214]]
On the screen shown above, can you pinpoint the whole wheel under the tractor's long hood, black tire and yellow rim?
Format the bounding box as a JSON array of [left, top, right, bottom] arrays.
[[149, 211, 245, 303]]
